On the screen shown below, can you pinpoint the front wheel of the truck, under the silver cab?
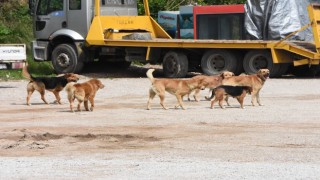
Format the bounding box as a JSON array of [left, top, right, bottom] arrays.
[[51, 44, 83, 74]]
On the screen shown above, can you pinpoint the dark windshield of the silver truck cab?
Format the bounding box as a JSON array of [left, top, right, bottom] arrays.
[[37, 0, 63, 15]]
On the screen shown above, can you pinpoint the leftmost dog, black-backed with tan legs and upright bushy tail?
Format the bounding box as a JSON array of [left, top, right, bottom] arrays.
[[22, 64, 79, 106]]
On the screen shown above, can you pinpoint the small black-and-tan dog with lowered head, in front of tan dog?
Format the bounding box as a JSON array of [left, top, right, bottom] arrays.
[[211, 85, 252, 109]]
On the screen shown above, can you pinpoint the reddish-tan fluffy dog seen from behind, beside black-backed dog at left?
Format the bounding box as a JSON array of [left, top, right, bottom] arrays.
[[66, 79, 104, 112]]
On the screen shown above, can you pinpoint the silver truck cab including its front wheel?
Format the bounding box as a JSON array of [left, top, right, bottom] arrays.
[[29, 0, 138, 73]]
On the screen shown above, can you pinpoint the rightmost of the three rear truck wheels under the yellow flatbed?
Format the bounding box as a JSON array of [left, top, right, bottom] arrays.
[[243, 50, 282, 77]]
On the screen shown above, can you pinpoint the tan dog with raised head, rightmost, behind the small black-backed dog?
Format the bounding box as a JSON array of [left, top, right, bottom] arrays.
[[222, 69, 270, 106]]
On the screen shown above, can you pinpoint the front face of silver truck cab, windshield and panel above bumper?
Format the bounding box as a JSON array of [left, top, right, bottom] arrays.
[[34, 0, 66, 39]]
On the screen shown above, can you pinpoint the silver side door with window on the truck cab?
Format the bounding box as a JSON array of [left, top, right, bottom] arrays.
[[66, 0, 93, 38]]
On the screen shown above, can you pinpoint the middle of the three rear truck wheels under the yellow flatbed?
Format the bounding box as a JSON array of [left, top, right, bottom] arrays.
[[201, 49, 238, 75]]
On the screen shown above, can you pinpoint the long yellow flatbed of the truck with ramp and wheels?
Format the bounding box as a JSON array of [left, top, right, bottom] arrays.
[[30, 0, 320, 77]]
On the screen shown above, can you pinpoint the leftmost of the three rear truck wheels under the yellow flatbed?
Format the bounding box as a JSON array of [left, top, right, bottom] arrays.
[[162, 51, 188, 78]]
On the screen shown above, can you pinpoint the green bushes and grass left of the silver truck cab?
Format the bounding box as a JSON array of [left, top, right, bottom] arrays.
[[0, 0, 54, 79]]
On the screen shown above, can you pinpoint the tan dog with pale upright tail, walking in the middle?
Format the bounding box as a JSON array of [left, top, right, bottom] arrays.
[[147, 69, 205, 110]]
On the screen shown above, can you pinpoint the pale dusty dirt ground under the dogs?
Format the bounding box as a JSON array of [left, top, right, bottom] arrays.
[[0, 65, 320, 179]]
